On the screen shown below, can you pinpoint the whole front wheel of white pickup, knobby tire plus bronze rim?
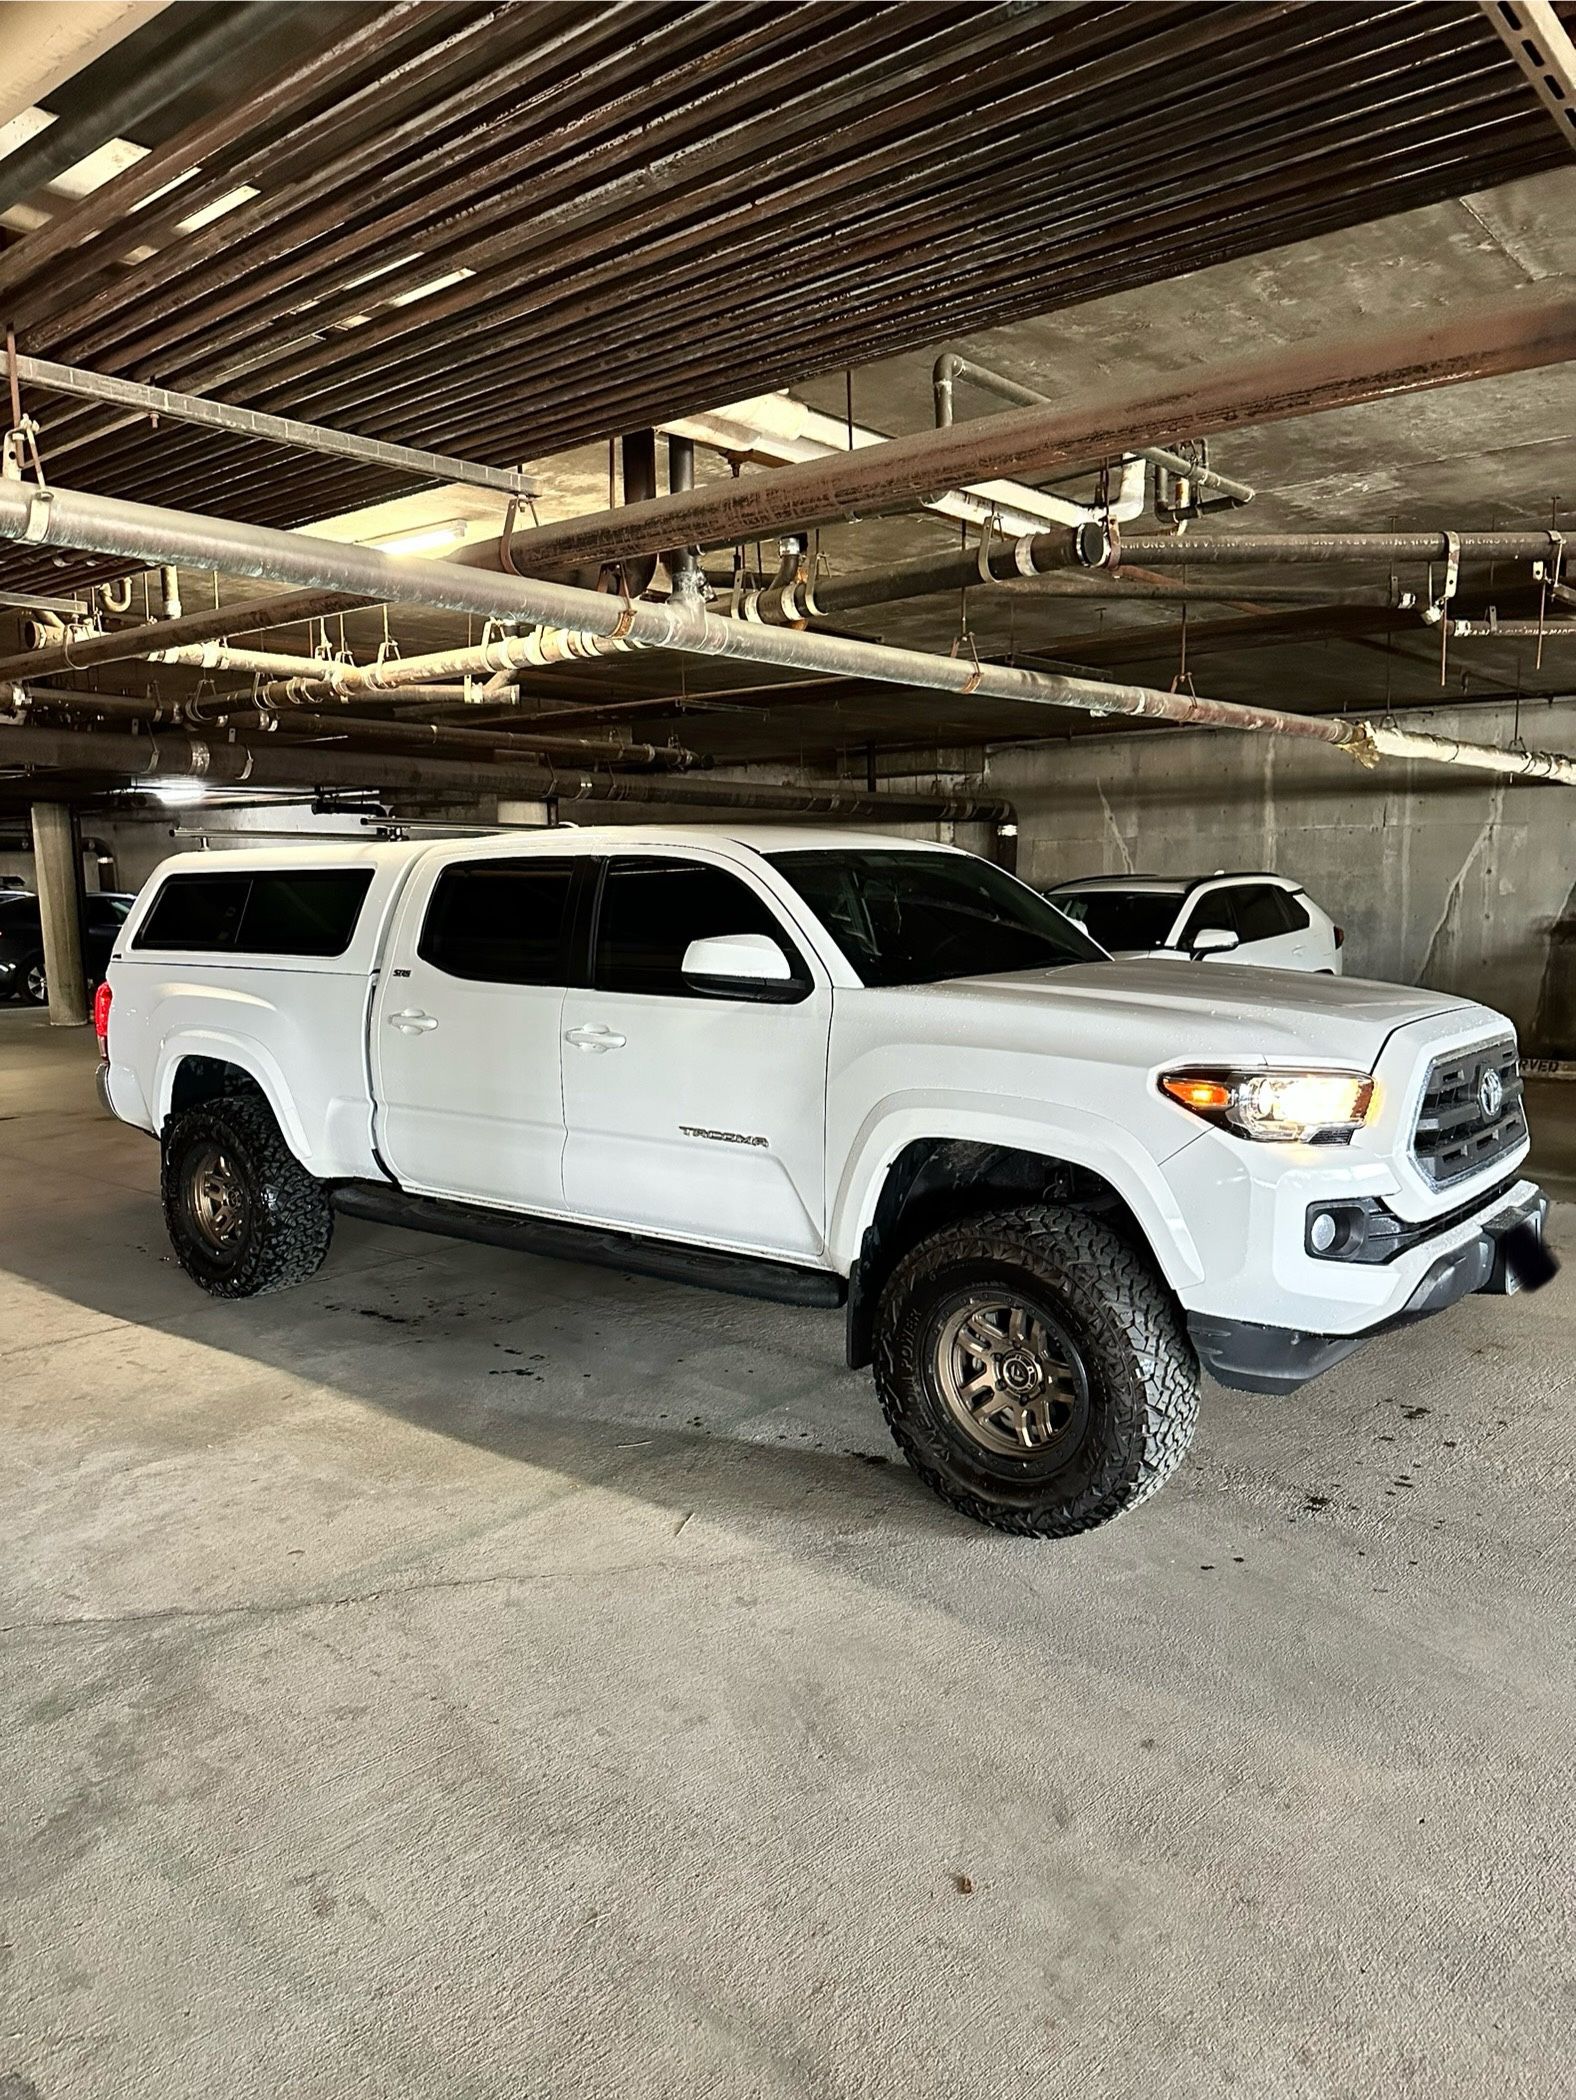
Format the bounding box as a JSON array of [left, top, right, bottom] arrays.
[[876, 1203, 1198, 1537]]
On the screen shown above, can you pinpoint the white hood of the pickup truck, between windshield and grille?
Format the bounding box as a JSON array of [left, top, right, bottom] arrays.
[[933, 960, 1500, 1065]]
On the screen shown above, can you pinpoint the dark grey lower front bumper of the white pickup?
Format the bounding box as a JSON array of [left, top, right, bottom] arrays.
[[1187, 1182, 1549, 1392]]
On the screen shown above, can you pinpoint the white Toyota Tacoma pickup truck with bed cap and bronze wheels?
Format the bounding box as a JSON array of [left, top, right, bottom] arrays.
[[99, 827, 1547, 1535]]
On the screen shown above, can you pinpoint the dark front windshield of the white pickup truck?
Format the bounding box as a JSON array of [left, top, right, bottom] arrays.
[[767, 848, 1105, 985]]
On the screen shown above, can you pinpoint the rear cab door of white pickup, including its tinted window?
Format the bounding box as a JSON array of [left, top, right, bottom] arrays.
[[372, 853, 595, 1212]]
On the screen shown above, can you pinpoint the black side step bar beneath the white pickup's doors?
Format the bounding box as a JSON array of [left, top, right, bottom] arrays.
[[332, 1182, 847, 1306]]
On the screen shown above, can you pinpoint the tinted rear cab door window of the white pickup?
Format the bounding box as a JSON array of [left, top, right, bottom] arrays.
[[418, 857, 584, 985]]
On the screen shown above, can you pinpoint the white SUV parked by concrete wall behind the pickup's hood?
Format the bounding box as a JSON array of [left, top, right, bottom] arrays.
[[1044, 869, 1345, 977]]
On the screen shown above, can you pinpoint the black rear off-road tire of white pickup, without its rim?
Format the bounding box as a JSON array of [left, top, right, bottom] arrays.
[[162, 1094, 334, 1298]]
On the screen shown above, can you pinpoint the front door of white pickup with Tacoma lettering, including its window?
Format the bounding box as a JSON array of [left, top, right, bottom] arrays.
[[563, 855, 832, 1258]]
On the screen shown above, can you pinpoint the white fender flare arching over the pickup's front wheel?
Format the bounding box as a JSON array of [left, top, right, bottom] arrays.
[[828, 1092, 1204, 1292]]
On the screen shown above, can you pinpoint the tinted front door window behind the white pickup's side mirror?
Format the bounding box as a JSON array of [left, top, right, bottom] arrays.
[[595, 859, 794, 998]]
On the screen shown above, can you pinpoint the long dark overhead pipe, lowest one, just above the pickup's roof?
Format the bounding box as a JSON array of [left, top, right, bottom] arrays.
[[0, 725, 1013, 823]]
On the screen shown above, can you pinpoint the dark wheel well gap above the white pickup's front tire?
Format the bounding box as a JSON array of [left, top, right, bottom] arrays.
[[847, 1138, 1154, 1369]]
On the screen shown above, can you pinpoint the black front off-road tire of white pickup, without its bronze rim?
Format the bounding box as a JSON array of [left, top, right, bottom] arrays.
[[876, 1203, 1200, 1539]]
